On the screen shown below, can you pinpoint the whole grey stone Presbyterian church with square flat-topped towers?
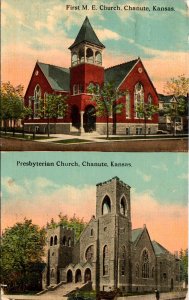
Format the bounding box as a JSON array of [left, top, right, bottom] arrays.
[[43, 177, 180, 293]]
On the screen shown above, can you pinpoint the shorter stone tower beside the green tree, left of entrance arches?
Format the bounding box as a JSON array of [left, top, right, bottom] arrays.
[[46, 225, 74, 286]]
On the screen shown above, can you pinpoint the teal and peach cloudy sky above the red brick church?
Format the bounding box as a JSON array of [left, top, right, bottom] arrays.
[[1, 0, 189, 93]]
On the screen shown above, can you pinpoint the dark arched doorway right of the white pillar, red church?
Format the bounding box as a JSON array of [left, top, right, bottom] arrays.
[[83, 105, 96, 132]]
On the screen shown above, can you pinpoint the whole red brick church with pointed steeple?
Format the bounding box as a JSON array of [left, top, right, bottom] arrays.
[[25, 17, 158, 134]]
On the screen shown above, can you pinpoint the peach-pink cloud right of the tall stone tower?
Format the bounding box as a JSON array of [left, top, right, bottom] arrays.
[[131, 191, 188, 252]]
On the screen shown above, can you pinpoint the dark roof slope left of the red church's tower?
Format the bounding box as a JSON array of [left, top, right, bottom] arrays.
[[37, 62, 70, 91]]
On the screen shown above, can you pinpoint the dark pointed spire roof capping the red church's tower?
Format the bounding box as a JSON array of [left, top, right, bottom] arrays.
[[69, 17, 105, 49]]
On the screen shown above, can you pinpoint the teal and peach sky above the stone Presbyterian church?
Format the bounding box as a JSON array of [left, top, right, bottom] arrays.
[[1, 152, 188, 252]]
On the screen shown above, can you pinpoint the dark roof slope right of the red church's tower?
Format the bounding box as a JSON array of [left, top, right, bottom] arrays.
[[105, 59, 139, 87]]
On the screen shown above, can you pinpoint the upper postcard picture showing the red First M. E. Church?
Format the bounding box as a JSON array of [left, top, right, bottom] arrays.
[[0, 0, 189, 152]]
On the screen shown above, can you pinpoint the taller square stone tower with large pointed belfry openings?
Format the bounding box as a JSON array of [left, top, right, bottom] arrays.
[[96, 177, 131, 291]]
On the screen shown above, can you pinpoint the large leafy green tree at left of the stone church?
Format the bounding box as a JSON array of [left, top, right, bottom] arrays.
[[0, 219, 45, 291]]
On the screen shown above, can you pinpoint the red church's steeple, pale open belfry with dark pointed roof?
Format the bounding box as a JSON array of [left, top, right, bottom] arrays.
[[69, 17, 105, 66]]
